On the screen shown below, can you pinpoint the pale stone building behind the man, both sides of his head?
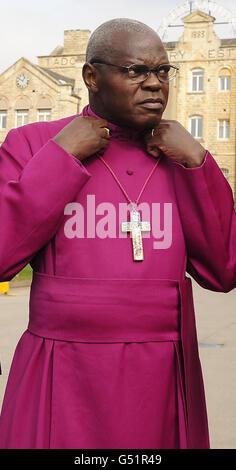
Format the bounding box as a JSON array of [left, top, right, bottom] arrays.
[[0, 10, 236, 195]]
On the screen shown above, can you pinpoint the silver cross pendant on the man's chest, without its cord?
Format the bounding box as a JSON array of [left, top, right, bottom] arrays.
[[121, 207, 151, 261]]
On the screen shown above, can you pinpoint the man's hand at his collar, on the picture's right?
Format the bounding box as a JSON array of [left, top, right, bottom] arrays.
[[145, 119, 206, 168]]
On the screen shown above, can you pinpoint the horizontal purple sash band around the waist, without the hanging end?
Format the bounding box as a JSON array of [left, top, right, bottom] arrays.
[[28, 271, 183, 342]]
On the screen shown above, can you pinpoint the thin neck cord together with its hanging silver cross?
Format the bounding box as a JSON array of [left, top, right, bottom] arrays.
[[98, 155, 161, 261]]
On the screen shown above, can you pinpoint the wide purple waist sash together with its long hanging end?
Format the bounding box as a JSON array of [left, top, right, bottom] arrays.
[[28, 271, 209, 449]]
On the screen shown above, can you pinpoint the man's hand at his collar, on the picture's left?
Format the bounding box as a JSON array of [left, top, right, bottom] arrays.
[[53, 116, 109, 160]]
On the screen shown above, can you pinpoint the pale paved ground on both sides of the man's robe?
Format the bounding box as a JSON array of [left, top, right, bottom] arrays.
[[0, 282, 236, 449]]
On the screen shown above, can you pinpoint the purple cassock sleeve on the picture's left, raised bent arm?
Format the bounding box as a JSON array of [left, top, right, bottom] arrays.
[[0, 126, 91, 281]]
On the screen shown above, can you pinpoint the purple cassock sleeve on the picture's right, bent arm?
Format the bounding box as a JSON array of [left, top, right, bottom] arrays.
[[174, 151, 236, 292]]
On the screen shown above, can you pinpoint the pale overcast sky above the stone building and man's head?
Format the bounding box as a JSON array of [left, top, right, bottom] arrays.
[[0, 0, 236, 73]]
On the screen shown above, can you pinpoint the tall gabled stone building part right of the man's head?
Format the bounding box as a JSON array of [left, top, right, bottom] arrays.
[[164, 11, 236, 195]]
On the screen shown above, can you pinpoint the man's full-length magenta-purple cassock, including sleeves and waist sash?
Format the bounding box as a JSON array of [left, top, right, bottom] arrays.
[[0, 106, 236, 449]]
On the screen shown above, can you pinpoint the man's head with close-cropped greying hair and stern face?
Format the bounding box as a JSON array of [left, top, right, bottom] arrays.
[[83, 18, 169, 130]]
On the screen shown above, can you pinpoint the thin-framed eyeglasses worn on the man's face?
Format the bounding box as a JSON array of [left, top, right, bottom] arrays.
[[90, 60, 179, 83]]
